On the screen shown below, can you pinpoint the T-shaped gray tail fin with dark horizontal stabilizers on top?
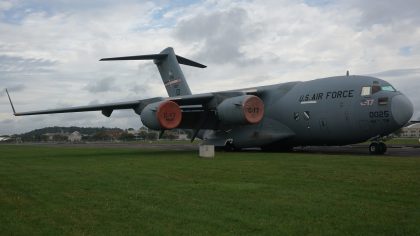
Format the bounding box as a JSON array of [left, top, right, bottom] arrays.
[[101, 47, 206, 97]]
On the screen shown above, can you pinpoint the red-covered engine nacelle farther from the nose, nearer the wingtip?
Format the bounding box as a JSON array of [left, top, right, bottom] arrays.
[[140, 101, 182, 130]]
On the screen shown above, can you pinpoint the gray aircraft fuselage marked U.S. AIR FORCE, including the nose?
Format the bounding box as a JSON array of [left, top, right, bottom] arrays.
[[203, 76, 413, 148]]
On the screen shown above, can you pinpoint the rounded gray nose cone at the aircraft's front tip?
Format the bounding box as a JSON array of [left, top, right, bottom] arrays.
[[391, 94, 413, 126]]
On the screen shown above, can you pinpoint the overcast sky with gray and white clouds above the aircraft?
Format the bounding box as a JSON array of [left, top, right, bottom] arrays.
[[0, 0, 420, 134]]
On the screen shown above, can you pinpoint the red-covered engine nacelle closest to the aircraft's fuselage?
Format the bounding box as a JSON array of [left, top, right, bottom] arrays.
[[217, 95, 264, 125]]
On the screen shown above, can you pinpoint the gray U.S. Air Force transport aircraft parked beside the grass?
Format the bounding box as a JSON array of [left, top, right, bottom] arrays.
[[8, 47, 413, 154]]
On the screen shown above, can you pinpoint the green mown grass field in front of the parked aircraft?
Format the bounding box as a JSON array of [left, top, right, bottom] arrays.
[[0, 146, 420, 235]]
